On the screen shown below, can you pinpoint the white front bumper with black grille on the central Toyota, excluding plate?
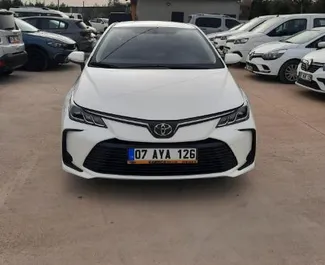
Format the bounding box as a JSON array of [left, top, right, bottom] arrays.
[[62, 104, 256, 177]]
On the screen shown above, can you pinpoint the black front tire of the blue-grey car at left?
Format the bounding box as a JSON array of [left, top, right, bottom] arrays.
[[24, 48, 49, 72]]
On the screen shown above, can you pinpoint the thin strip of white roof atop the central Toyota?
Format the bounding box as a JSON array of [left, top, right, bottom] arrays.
[[114, 21, 195, 29]]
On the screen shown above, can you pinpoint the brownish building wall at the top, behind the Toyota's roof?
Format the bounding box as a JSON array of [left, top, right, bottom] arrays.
[[137, 0, 240, 22]]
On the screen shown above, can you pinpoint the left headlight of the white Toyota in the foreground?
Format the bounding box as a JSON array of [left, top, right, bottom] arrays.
[[69, 99, 107, 128]]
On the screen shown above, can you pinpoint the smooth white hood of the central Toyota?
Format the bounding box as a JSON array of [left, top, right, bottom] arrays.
[[73, 67, 244, 120]]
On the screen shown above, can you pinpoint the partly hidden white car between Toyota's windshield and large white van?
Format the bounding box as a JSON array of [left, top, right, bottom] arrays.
[[208, 15, 276, 50]]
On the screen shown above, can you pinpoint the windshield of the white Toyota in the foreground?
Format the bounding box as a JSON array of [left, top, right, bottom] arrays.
[[89, 27, 224, 69]]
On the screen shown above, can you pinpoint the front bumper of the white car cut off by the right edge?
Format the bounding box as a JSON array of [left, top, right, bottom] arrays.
[[296, 64, 325, 93]]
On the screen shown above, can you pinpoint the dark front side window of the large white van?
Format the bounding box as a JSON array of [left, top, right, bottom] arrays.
[[268, 19, 307, 37]]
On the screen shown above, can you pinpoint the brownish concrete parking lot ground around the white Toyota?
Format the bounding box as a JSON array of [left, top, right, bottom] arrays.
[[0, 65, 325, 265]]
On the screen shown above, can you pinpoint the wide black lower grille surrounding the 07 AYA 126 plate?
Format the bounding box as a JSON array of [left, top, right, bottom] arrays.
[[84, 139, 237, 176]]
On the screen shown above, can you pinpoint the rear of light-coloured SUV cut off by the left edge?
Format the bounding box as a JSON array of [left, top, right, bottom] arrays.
[[0, 9, 27, 75]]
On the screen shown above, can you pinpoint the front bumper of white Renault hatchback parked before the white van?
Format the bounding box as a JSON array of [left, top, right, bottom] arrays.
[[246, 56, 283, 76]]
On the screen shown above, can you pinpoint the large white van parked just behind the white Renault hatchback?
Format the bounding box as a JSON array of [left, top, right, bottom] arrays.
[[224, 14, 325, 63]]
